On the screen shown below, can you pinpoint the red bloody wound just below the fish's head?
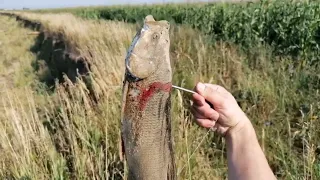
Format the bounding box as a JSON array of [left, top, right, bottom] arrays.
[[139, 82, 172, 111]]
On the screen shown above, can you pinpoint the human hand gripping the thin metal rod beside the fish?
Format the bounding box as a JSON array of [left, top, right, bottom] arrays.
[[192, 83, 250, 135]]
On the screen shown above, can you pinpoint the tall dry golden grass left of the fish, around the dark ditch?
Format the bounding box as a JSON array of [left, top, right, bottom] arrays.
[[0, 14, 134, 179]]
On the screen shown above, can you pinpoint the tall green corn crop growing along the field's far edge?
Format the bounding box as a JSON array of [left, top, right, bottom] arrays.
[[38, 0, 320, 64]]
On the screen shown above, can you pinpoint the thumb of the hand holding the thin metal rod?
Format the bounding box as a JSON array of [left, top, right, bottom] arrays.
[[196, 83, 224, 107]]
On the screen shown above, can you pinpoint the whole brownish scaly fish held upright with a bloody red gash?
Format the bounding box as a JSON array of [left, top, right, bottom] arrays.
[[121, 15, 176, 180]]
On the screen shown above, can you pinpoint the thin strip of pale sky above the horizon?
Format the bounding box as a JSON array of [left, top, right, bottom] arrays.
[[0, 0, 209, 9]]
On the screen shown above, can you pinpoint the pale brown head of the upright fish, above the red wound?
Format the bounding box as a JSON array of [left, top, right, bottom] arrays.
[[126, 15, 170, 79]]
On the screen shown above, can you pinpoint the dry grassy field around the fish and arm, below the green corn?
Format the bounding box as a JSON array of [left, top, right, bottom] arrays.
[[0, 3, 320, 179]]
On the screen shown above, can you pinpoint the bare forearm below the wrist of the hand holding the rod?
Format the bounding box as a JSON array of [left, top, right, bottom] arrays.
[[226, 119, 275, 180]]
